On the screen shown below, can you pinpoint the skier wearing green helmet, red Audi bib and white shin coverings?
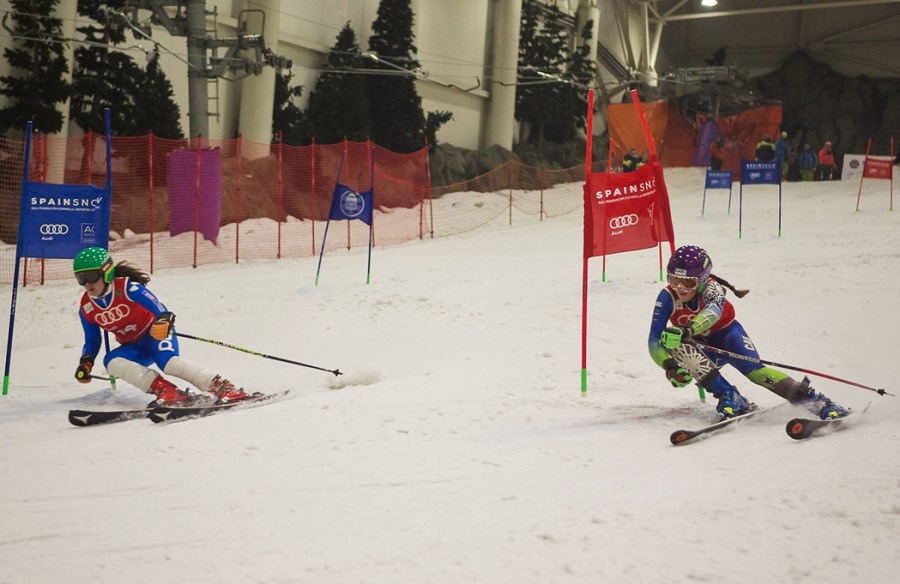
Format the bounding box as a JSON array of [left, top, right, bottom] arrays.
[[73, 247, 255, 405]]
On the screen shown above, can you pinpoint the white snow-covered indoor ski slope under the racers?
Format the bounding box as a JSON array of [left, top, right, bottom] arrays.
[[0, 169, 900, 584]]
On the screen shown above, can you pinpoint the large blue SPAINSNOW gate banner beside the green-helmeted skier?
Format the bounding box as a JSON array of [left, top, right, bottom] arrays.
[[19, 180, 112, 259]]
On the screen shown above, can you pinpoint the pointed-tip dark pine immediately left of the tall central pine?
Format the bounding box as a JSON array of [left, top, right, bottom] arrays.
[[306, 22, 369, 144]]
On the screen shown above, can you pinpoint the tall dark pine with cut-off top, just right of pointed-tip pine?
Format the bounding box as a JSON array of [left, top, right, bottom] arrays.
[[365, 0, 425, 152]]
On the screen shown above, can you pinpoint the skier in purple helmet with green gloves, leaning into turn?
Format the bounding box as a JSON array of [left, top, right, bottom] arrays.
[[648, 245, 849, 420]]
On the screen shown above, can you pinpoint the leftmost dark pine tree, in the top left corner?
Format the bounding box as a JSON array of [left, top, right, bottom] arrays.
[[0, 0, 70, 134]]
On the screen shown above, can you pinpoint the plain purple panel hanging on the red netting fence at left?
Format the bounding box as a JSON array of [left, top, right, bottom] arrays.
[[168, 148, 222, 243]]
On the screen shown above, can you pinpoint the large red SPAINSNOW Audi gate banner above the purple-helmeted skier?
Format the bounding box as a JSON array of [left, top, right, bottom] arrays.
[[584, 156, 675, 258]]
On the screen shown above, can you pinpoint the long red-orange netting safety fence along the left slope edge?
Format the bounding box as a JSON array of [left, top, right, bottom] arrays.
[[0, 133, 584, 285]]
